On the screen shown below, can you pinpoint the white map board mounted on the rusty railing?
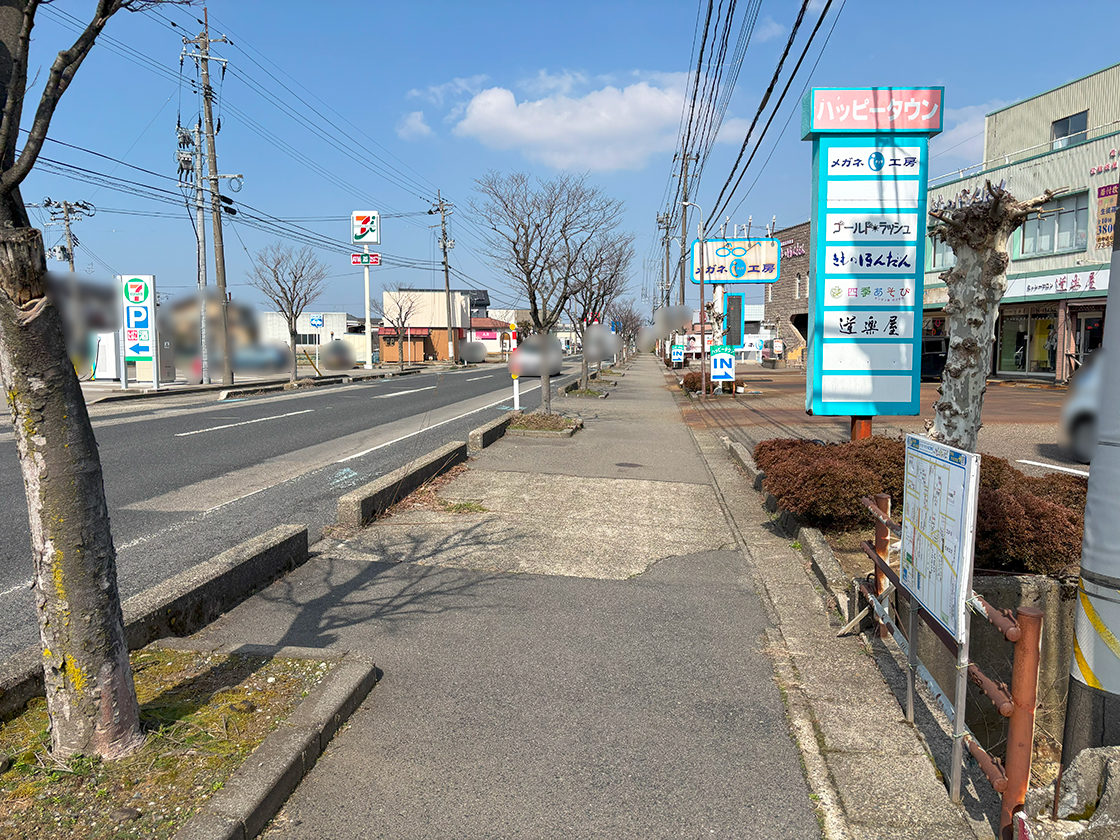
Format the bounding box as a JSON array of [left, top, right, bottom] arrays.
[[900, 435, 980, 643]]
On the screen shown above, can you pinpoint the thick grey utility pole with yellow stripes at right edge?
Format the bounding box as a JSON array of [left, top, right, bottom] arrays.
[[1062, 175, 1120, 766]]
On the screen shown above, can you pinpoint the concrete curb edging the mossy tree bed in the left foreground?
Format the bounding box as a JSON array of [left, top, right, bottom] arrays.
[[164, 644, 379, 840]]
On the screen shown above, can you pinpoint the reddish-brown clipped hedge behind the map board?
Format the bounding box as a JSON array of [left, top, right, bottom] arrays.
[[754, 437, 1088, 575]]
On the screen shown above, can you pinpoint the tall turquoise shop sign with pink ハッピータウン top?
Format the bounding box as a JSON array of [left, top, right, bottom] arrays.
[[802, 87, 942, 417]]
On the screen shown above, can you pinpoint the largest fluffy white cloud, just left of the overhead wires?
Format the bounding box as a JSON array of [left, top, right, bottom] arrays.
[[454, 73, 688, 171]]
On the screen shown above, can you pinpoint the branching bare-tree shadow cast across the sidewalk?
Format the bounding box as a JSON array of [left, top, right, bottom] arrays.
[[247, 523, 515, 647]]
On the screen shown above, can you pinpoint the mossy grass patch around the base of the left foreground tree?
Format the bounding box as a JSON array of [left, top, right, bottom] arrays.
[[0, 650, 332, 840]]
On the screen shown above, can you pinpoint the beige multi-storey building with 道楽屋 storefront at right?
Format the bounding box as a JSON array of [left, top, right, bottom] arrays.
[[923, 65, 1120, 382]]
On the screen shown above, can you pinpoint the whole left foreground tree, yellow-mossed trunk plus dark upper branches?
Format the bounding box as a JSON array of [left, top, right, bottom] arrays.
[[0, 0, 192, 758]]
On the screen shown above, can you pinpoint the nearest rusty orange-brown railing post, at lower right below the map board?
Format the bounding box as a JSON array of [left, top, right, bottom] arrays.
[[999, 607, 1043, 840]]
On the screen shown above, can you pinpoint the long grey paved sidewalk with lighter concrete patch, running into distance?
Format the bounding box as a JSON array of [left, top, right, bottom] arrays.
[[176, 358, 990, 840]]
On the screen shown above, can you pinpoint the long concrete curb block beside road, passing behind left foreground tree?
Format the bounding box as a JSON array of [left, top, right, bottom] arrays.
[[0, 525, 308, 720]]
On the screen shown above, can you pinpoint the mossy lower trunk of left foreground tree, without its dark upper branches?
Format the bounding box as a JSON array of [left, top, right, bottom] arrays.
[[0, 228, 143, 758]]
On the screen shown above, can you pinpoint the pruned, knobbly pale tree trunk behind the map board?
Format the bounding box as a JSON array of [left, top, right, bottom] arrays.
[[915, 181, 1055, 452]]
